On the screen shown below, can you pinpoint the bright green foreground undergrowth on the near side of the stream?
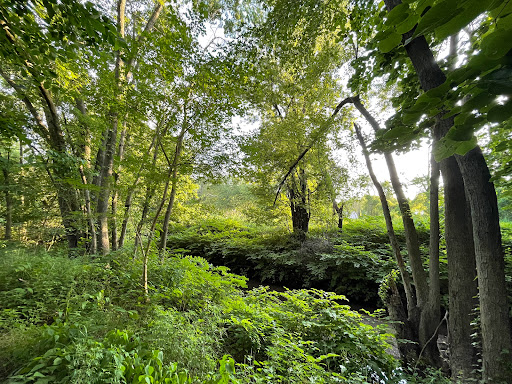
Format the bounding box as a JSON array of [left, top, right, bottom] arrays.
[[0, 237, 450, 383]]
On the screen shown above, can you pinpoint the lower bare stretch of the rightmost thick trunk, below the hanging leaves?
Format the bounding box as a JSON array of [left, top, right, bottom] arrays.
[[456, 147, 512, 383]]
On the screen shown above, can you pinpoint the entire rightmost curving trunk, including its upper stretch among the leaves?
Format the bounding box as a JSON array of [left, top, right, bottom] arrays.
[[385, 0, 512, 383]]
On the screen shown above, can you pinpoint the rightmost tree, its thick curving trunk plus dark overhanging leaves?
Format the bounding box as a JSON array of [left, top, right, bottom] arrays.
[[381, 0, 512, 382]]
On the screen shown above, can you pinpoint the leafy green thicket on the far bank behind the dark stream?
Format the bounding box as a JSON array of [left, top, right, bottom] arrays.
[[168, 217, 434, 308]]
